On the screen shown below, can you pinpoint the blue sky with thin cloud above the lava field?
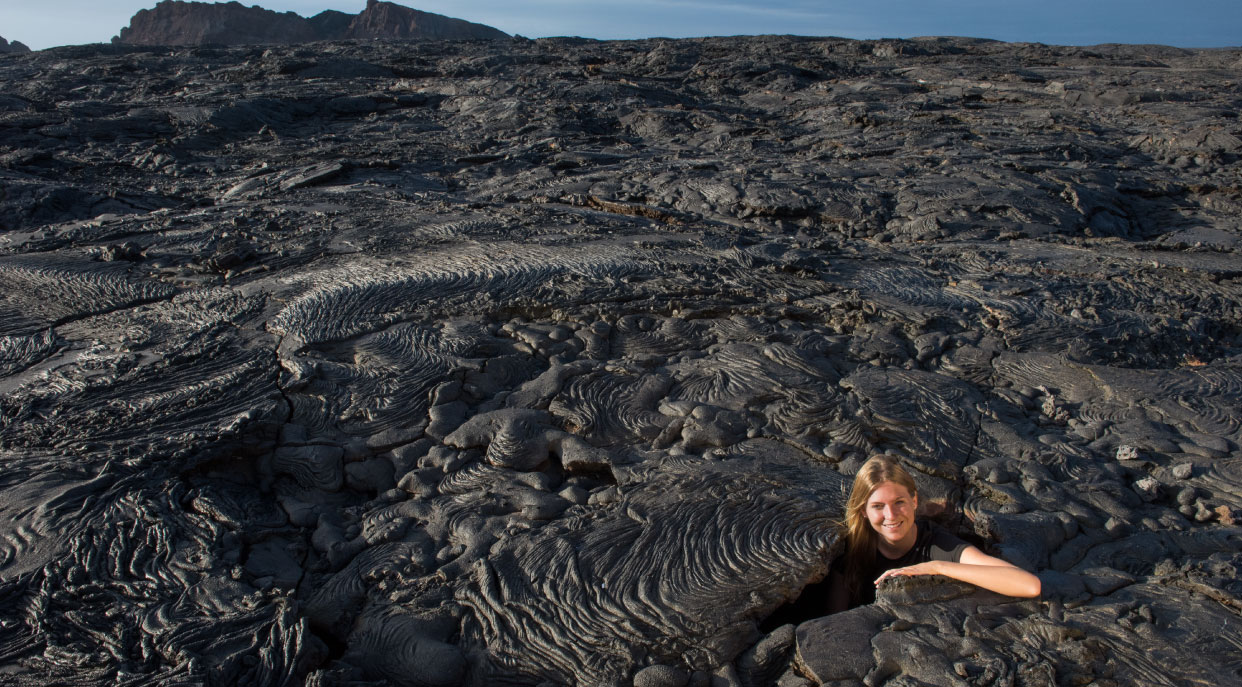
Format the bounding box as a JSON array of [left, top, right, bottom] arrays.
[[0, 0, 1242, 50]]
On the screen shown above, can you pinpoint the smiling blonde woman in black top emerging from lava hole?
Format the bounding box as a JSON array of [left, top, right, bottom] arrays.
[[828, 456, 1040, 612]]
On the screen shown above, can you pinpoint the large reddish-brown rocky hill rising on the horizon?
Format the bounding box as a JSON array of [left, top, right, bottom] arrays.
[[111, 0, 509, 47]]
